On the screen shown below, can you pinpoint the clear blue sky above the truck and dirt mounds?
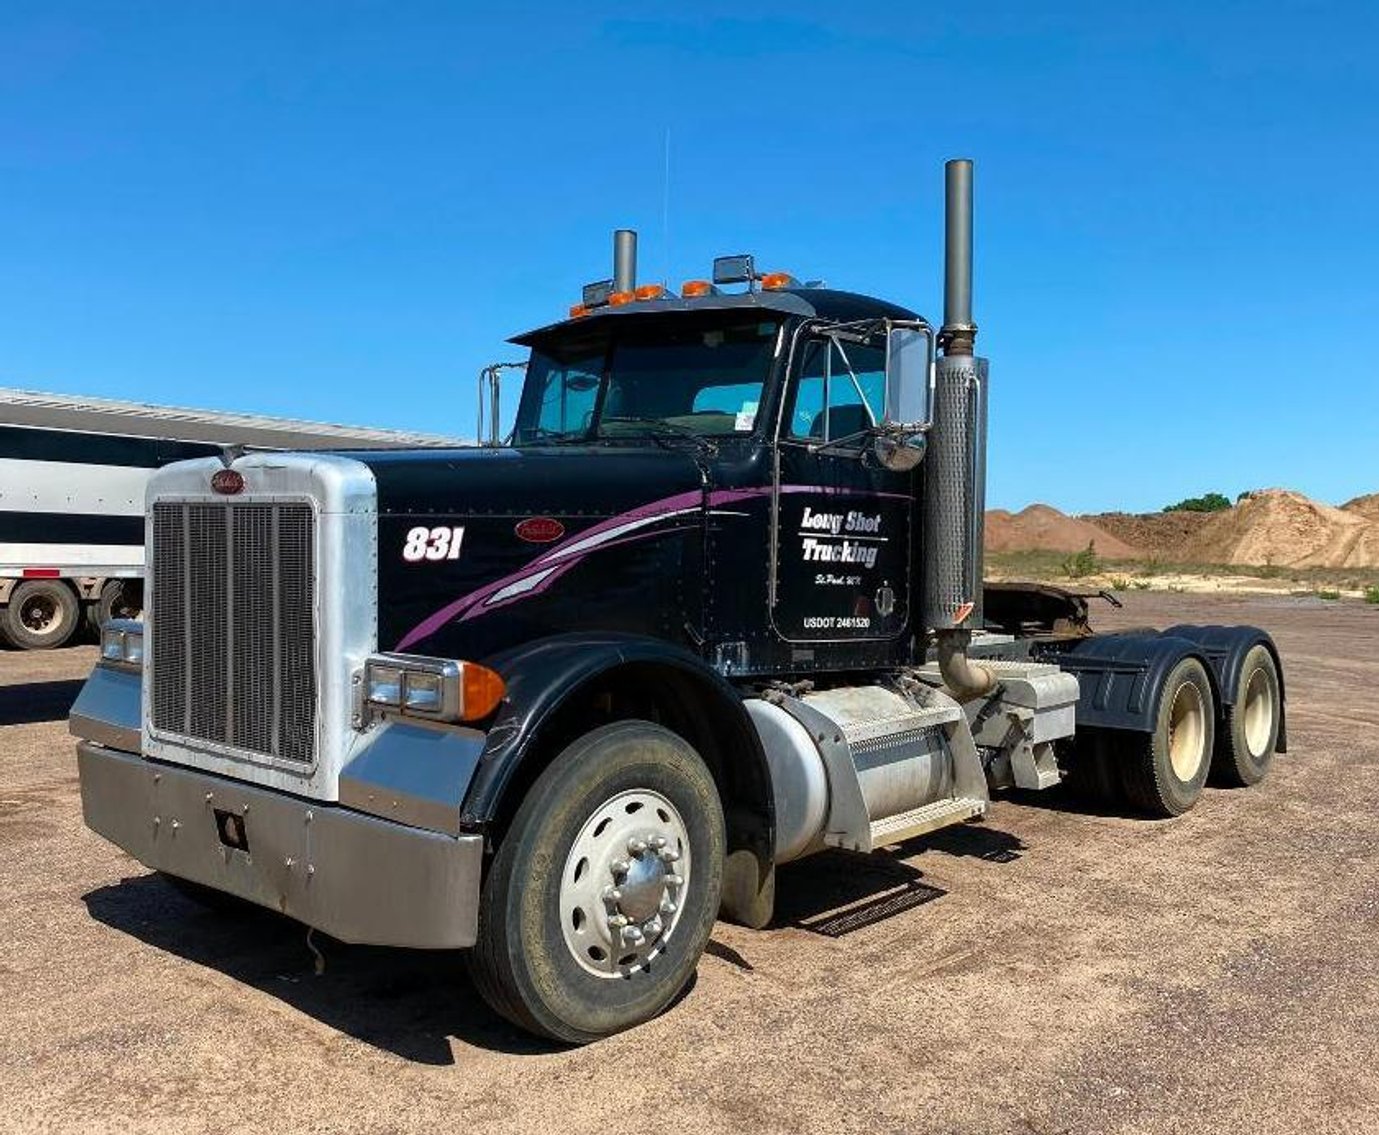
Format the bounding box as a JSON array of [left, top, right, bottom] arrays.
[[0, 0, 1379, 510]]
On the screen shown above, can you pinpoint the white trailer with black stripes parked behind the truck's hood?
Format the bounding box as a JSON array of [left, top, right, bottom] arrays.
[[0, 389, 463, 650]]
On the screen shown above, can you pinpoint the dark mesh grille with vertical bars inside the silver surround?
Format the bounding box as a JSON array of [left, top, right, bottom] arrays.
[[150, 501, 316, 763]]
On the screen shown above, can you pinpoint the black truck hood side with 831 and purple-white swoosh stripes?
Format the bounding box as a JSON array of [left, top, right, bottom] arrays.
[[348, 447, 706, 661]]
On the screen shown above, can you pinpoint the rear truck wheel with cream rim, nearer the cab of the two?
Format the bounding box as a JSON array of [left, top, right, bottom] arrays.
[[1121, 658, 1216, 816]]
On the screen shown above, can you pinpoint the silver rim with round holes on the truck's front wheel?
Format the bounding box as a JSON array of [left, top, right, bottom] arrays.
[[560, 789, 691, 978]]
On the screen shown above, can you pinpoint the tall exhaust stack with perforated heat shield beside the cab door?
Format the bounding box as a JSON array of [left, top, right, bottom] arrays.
[[924, 159, 996, 701]]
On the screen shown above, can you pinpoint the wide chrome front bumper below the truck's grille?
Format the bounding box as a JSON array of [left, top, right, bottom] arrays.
[[77, 741, 483, 949]]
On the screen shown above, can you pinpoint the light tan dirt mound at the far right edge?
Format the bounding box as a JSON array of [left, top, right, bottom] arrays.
[[1185, 488, 1379, 567]]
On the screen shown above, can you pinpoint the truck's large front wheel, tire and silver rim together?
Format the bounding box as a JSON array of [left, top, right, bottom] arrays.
[[469, 721, 725, 1044]]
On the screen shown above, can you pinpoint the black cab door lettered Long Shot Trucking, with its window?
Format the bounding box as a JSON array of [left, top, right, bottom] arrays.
[[771, 331, 918, 644]]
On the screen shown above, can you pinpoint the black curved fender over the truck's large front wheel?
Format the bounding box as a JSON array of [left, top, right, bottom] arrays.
[[461, 633, 775, 927]]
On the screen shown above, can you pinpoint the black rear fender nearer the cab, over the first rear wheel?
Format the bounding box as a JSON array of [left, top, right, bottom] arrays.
[[1051, 630, 1220, 732]]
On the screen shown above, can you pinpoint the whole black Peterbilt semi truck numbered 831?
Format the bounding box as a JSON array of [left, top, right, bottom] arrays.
[[72, 161, 1284, 1043]]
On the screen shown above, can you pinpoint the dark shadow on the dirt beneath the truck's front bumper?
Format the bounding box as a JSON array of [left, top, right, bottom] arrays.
[[83, 874, 563, 1065]]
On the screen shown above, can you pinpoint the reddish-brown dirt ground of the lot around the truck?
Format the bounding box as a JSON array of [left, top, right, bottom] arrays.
[[0, 593, 1379, 1135]]
